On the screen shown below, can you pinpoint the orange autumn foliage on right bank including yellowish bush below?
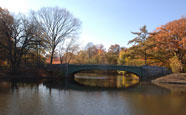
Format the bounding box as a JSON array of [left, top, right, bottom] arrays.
[[130, 17, 186, 72]]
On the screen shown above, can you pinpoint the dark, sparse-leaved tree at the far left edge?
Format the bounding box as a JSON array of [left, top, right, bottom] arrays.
[[0, 9, 37, 71]]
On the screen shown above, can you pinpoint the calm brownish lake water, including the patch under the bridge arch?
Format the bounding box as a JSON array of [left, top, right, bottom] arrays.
[[0, 75, 186, 115]]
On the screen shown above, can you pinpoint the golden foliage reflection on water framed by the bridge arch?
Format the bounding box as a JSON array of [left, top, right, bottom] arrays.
[[75, 73, 139, 88]]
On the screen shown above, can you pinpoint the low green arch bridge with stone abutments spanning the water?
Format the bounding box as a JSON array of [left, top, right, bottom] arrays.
[[47, 64, 171, 80]]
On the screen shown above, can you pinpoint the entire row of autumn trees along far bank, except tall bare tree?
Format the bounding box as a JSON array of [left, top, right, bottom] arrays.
[[0, 8, 186, 73]]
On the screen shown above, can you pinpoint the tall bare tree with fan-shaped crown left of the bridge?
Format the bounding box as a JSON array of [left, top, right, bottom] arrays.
[[32, 7, 81, 64]]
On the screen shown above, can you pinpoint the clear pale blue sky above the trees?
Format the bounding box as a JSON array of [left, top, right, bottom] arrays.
[[0, 0, 186, 48]]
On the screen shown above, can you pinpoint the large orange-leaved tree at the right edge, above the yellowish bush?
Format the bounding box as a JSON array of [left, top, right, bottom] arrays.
[[151, 17, 186, 67]]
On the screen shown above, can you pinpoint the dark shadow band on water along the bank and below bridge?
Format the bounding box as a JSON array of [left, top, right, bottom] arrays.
[[0, 74, 170, 95]]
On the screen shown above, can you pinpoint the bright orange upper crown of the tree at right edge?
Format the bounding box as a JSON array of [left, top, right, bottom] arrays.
[[153, 18, 186, 50]]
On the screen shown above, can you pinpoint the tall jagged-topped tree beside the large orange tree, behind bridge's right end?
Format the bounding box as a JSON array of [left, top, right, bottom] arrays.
[[128, 25, 149, 65]]
